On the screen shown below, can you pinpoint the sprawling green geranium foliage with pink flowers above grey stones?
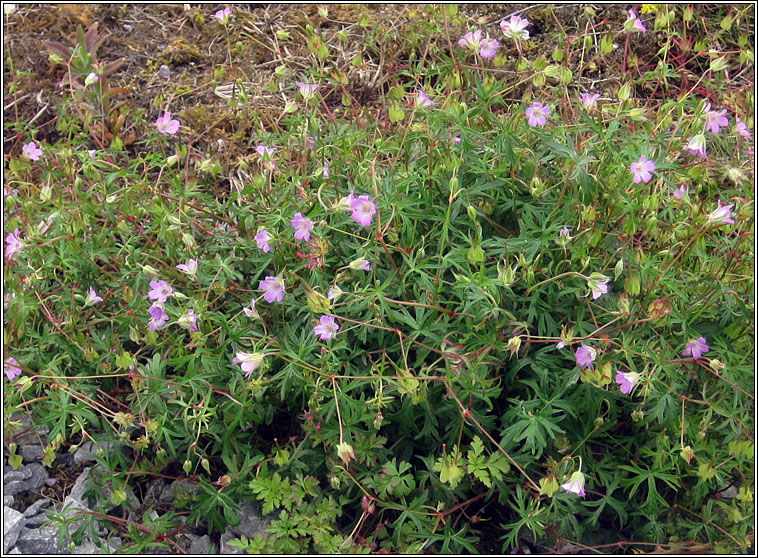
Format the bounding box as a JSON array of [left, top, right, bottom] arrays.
[[4, 5, 755, 553]]
